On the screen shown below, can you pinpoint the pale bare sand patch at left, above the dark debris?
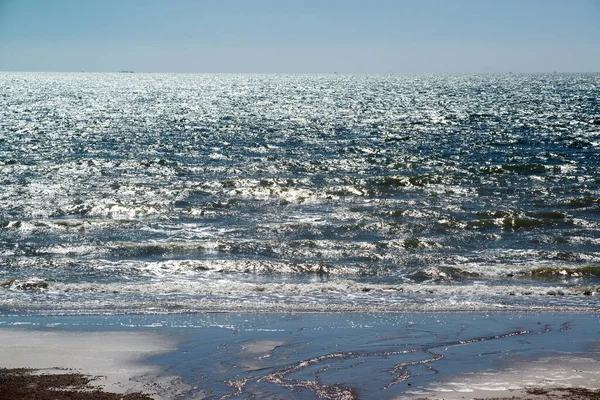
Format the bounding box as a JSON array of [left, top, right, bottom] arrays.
[[0, 329, 185, 399]]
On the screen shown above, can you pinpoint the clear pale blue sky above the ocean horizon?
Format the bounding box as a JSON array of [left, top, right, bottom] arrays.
[[0, 0, 600, 73]]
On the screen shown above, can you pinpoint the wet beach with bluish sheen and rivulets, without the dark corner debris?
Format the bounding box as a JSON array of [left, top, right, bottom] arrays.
[[0, 313, 600, 400]]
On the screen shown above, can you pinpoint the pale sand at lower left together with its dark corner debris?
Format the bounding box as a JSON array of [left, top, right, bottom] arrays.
[[0, 329, 188, 400]]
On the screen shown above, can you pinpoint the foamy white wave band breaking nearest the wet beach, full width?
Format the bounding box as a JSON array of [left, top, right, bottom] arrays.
[[0, 278, 600, 313]]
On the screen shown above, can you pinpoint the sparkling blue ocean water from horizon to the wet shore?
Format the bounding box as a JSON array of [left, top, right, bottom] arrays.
[[0, 72, 600, 313]]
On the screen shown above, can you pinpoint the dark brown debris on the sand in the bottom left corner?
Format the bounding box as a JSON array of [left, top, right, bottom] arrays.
[[0, 368, 152, 400]]
